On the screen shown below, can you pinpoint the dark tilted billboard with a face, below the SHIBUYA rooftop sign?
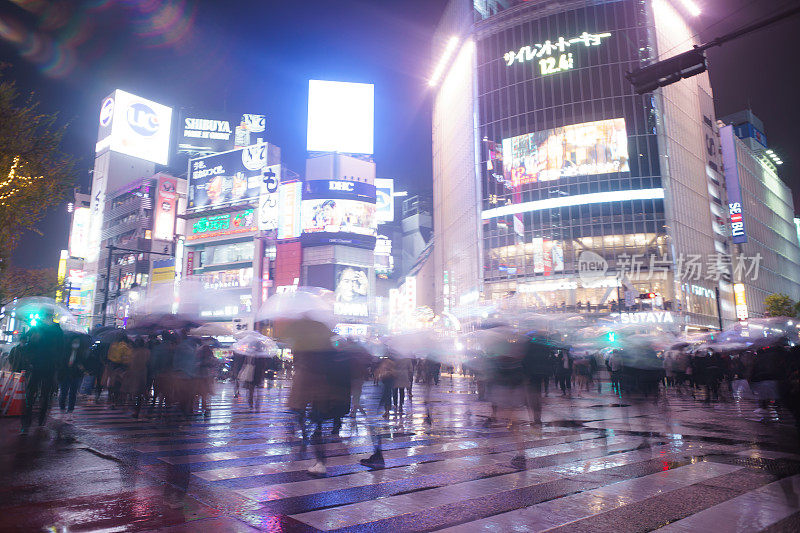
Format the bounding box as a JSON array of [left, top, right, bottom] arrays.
[[188, 143, 280, 210]]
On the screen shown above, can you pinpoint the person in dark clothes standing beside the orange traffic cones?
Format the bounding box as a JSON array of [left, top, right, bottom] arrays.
[[22, 313, 64, 433]]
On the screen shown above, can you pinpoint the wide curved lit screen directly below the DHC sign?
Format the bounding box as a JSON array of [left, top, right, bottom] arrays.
[[301, 199, 377, 236]]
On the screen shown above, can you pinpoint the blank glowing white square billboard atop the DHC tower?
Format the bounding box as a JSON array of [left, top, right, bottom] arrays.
[[307, 80, 375, 154]]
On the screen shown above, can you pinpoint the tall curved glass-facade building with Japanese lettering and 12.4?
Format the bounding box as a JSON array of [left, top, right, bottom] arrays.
[[433, 0, 733, 327]]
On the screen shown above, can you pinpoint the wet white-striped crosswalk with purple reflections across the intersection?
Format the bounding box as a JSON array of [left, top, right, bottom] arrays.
[[47, 379, 800, 532]]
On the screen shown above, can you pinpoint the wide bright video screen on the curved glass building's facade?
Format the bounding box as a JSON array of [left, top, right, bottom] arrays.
[[503, 118, 630, 187]]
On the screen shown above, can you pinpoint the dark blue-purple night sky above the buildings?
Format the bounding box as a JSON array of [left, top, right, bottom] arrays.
[[0, 0, 800, 267]]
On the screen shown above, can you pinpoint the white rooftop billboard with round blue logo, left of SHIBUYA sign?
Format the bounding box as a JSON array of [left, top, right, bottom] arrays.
[[96, 89, 172, 165]]
